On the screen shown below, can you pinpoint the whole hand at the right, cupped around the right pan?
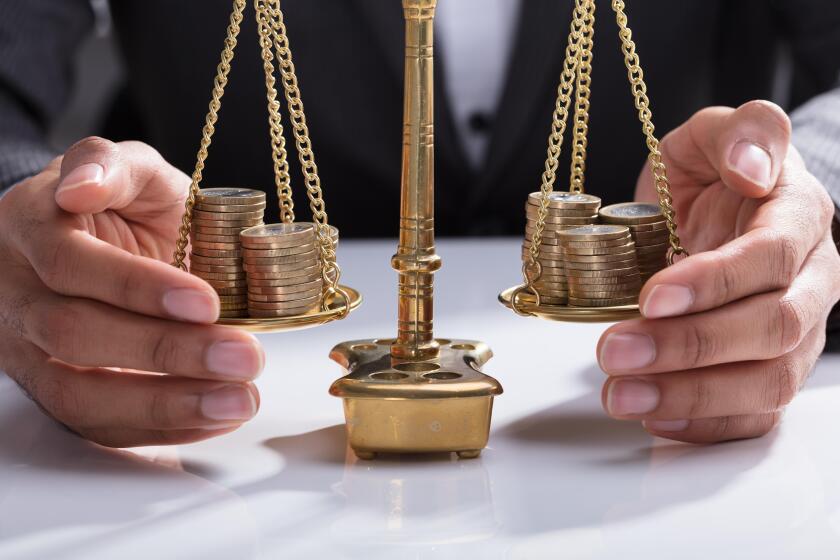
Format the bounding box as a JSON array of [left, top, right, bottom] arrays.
[[598, 101, 840, 443]]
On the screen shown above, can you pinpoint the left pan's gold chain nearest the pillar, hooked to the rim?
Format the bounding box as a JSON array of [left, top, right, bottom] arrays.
[[266, 0, 350, 314]]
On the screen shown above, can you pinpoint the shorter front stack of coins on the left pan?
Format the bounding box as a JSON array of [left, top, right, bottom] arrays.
[[239, 223, 328, 317]]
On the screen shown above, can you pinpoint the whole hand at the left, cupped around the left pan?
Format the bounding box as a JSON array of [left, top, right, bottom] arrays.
[[0, 138, 264, 447]]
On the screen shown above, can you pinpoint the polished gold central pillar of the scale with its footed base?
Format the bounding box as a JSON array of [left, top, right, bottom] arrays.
[[330, 0, 502, 459]]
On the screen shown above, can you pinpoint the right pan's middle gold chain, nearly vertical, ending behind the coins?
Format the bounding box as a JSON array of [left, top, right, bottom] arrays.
[[569, 0, 595, 193]]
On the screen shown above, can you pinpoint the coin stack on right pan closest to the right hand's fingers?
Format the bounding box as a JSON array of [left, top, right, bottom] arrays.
[[599, 202, 669, 283]]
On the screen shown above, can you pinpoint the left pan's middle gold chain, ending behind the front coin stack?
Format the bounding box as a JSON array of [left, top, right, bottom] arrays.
[[254, 0, 295, 224]]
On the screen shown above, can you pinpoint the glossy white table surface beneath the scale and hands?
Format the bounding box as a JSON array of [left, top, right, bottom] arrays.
[[0, 240, 840, 560]]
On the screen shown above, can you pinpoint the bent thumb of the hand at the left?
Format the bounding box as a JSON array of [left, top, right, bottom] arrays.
[[55, 137, 183, 214]]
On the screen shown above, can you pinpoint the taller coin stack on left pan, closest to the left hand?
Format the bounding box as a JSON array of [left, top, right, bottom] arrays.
[[190, 189, 265, 318]]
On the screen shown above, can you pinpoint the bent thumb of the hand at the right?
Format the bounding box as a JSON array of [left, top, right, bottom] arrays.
[[663, 101, 791, 198]]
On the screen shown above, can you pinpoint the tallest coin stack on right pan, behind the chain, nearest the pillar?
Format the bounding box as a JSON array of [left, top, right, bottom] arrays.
[[522, 191, 601, 305]]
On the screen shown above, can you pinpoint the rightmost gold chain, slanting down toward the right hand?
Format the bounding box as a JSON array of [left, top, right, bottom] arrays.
[[612, 0, 688, 264]]
